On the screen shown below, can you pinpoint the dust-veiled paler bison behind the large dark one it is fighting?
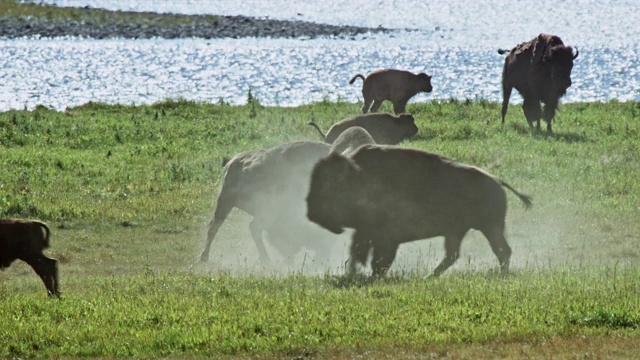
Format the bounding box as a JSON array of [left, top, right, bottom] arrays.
[[200, 141, 335, 262]]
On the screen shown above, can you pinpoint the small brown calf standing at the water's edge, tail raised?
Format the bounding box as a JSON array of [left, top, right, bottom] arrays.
[[349, 69, 433, 114]]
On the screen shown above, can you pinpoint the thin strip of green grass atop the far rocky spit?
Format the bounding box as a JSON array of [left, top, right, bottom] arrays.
[[0, 0, 217, 26]]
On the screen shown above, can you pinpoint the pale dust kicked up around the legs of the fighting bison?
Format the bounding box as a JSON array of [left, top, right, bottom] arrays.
[[192, 174, 640, 276]]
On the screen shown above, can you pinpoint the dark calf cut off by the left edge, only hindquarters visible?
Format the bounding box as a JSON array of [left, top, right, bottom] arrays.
[[0, 219, 60, 297]]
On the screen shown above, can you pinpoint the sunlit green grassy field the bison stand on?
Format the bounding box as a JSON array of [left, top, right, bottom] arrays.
[[0, 97, 640, 359]]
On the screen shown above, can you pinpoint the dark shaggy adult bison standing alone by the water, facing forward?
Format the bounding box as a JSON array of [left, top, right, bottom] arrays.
[[498, 34, 578, 132]]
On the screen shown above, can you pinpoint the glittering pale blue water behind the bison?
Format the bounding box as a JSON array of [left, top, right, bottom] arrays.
[[5, 0, 640, 111]]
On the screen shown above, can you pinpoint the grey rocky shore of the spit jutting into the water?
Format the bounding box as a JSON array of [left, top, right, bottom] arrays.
[[0, 12, 389, 39]]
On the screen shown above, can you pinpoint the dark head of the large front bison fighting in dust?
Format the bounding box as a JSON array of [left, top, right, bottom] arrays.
[[307, 153, 359, 234]]
